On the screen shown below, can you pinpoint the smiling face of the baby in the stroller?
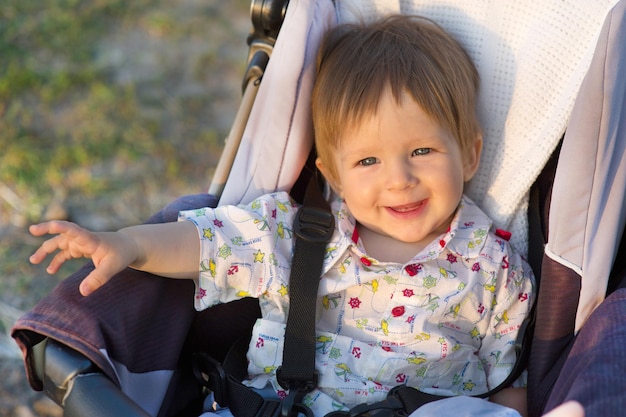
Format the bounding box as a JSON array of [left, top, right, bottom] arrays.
[[321, 91, 480, 254]]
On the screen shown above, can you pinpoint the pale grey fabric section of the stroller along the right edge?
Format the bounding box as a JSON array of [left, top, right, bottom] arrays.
[[546, 1, 626, 330]]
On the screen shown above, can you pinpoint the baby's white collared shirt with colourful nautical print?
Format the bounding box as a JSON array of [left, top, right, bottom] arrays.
[[179, 192, 534, 415]]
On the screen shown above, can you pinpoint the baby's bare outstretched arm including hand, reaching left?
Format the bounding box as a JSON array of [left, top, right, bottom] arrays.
[[30, 221, 200, 296]]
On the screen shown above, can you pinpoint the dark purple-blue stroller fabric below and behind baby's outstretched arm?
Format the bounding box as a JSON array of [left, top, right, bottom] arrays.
[[12, 194, 260, 416]]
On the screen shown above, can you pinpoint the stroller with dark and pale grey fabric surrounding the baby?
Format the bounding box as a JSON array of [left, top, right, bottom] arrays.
[[12, 0, 626, 416]]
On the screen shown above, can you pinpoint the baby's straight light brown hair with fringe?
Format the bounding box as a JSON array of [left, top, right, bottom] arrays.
[[312, 15, 481, 177]]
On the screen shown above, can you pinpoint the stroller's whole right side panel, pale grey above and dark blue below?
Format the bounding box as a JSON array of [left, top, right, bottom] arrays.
[[528, 1, 626, 416]]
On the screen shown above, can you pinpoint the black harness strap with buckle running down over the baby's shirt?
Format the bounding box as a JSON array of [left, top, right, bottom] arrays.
[[194, 175, 335, 417]]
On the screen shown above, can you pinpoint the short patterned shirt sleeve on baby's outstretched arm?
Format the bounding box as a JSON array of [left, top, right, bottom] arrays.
[[179, 192, 299, 310]]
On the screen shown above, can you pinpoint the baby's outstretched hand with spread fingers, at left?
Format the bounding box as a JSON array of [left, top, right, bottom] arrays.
[[29, 221, 136, 296]]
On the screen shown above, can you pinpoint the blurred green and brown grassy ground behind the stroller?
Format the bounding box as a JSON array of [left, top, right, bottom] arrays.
[[0, 0, 250, 416]]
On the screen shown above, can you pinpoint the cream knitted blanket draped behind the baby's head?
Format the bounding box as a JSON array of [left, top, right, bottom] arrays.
[[336, 0, 616, 254]]
